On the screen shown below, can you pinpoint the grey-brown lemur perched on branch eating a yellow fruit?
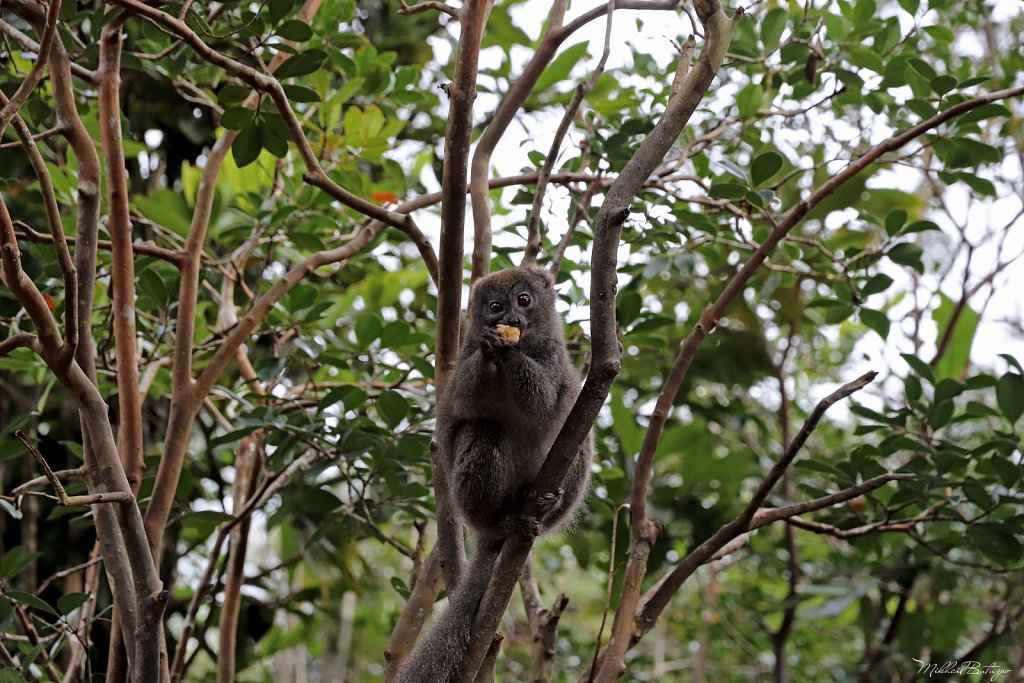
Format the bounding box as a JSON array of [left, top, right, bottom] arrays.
[[398, 267, 594, 683]]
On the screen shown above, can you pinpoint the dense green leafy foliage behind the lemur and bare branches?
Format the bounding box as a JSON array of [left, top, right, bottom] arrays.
[[0, 0, 1024, 683]]
